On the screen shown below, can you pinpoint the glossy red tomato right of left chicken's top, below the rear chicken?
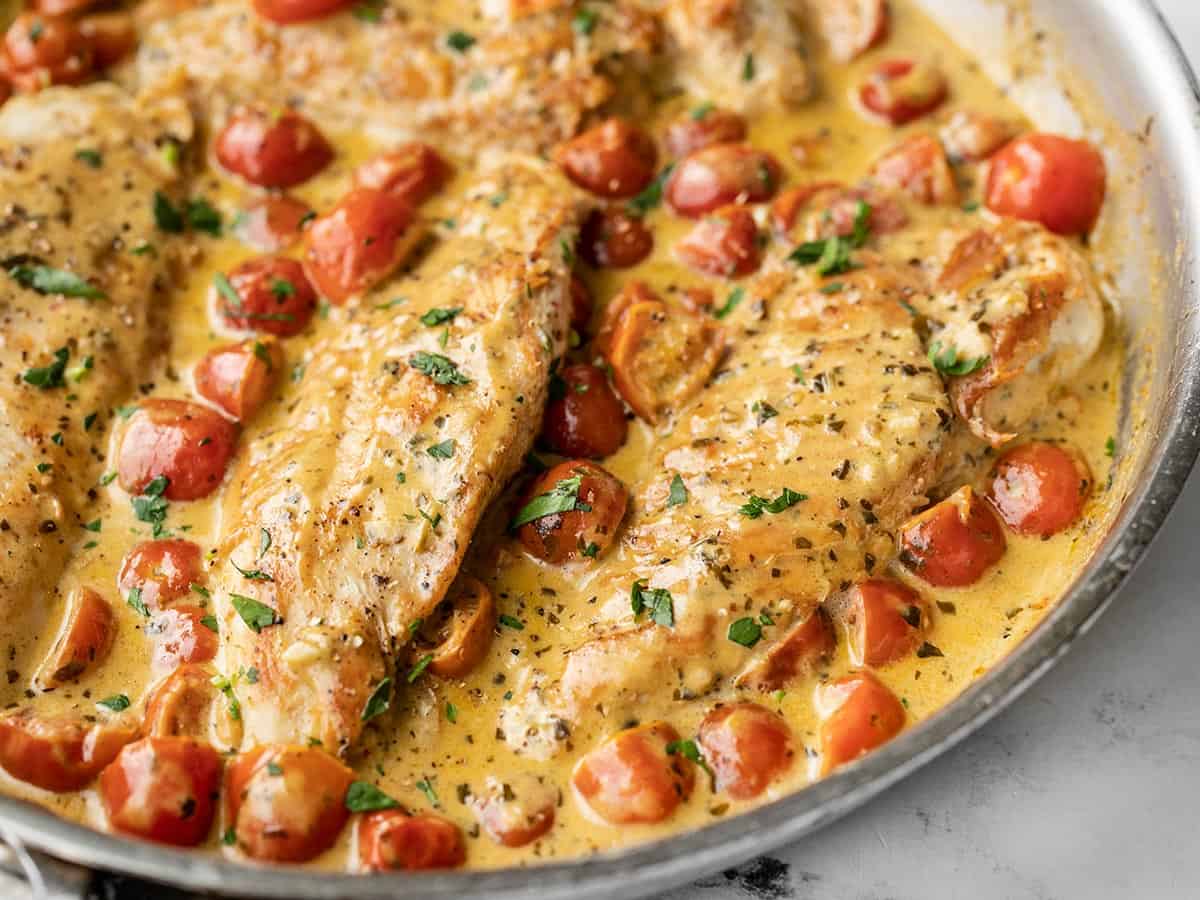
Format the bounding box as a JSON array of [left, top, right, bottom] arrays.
[[214, 109, 334, 187]]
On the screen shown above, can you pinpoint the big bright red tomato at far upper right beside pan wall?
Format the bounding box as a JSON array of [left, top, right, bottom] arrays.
[[985, 133, 1106, 234]]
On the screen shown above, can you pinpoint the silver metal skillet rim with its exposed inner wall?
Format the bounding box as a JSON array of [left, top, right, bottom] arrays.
[[0, 0, 1200, 900]]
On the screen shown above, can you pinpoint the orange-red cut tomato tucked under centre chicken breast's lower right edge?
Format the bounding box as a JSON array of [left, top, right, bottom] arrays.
[[414, 574, 496, 678]]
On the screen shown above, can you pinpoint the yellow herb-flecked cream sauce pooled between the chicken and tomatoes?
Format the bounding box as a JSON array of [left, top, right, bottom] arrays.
[[2, 0, 1122, 869]]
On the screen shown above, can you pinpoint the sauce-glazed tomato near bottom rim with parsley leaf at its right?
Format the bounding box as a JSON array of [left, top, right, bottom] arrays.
[[571, 722, 696, 824]]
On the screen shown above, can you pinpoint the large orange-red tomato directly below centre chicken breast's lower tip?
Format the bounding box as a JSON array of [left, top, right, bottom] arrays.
[[226, 744, 354, 863]]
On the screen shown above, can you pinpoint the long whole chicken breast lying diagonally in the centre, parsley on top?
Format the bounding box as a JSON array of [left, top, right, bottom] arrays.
[[212, 160, 582, 751]]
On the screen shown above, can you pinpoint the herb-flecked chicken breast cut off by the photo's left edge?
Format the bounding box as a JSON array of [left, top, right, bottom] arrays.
[[0, 85, 192, 631]]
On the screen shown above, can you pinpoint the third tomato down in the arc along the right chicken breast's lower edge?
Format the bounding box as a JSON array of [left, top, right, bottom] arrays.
[[846, 578, 929, 667]]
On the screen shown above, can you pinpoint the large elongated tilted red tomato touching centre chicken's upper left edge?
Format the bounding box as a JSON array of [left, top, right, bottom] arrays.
[[305, 187, 413, 304]]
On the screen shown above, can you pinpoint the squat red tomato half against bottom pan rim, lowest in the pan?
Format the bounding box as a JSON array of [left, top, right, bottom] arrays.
[[359, 809, 467, 872]]
